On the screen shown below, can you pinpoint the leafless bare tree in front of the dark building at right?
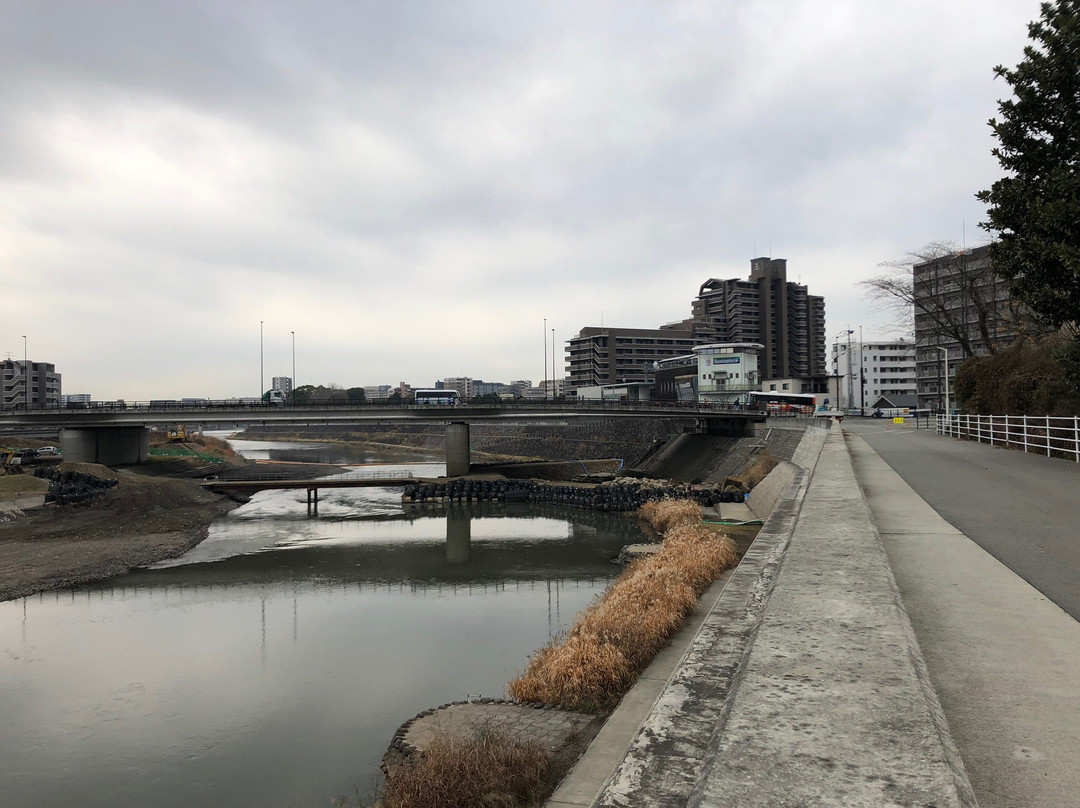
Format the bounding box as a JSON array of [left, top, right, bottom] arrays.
[[860, 241, 1030, 358]]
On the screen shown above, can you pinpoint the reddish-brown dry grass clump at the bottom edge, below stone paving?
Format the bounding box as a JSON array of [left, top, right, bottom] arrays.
[[380, 732, 551, 808]]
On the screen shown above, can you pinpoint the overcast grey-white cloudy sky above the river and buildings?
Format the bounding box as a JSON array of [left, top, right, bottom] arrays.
[[0, 0, 1039, 400]]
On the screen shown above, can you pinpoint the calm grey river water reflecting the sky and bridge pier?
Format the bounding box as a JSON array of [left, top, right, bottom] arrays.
[[0, 442, 642, 808]]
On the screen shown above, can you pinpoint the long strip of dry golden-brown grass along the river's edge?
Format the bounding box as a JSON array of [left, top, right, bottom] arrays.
[[509, 500, 737, 712]]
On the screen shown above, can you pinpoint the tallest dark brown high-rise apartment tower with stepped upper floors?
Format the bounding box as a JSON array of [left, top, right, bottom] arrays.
[[667, 258, 828, 379]]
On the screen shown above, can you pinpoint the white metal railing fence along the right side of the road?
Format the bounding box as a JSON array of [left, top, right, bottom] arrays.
[[937, 415, 1080, 462]]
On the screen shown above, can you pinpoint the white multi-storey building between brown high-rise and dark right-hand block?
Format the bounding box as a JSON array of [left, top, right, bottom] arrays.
[[832, 339, 917, 409]]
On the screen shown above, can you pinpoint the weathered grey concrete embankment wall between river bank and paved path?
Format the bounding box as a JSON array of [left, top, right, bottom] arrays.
[[550, 419, 975, 808]]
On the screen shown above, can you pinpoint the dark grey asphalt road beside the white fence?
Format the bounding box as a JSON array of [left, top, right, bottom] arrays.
[[843, 418, 1080, 620]]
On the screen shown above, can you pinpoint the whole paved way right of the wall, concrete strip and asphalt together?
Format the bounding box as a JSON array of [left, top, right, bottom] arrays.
[[843, 419, 1080, 808]]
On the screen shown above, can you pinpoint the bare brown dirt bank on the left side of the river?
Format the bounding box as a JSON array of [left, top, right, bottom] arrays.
[[0, 463, 237, 601]]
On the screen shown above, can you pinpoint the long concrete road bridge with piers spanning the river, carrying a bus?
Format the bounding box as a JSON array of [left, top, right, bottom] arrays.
[[0, 402, 766, 476]]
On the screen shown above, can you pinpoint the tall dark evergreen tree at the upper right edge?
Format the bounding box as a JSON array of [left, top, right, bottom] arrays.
[[976, 0, 1080, 328]]
